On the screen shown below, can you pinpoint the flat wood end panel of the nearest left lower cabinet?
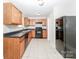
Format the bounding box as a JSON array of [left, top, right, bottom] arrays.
[[3, 38, 20, 59]]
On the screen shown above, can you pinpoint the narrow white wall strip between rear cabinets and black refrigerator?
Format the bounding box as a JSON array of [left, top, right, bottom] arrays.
[[47, 12, 55, 48]]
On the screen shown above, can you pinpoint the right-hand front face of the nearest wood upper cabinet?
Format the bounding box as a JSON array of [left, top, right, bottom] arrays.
[[12, 5, 22, 25]]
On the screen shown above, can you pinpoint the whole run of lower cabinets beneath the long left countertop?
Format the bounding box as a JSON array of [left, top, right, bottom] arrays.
[[3, 31, 32, 59]]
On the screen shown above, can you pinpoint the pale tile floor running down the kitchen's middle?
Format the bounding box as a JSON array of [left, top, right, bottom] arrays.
[[22, 39, 75, 59]]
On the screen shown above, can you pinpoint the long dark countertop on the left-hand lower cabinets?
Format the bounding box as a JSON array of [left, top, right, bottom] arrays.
[[4, 30, 31, 38]]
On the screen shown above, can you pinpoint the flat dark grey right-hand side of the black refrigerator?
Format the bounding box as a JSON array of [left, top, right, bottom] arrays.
[[64, 16, 76, 57]]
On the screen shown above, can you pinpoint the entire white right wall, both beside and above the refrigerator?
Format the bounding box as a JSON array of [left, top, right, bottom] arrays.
[[48, 0, 76, 48]]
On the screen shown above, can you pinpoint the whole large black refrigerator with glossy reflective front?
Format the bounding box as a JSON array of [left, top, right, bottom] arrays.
[[56, 16, 76, 59]]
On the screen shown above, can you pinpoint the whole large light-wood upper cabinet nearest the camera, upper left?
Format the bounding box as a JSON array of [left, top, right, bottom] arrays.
[[3, 3, 22, 25]]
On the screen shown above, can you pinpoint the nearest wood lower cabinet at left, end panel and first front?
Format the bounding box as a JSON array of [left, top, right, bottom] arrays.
[[4, 38, 25, 59]]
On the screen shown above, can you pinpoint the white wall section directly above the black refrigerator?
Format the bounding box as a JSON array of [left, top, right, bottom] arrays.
[[53, 0, 76, 19]]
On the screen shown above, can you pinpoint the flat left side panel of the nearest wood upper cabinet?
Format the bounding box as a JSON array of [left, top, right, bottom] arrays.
[[3, 3, 12, 24]]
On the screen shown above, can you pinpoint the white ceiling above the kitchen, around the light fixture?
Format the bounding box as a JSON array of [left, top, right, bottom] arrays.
[[4, 0, 68, 17]]
